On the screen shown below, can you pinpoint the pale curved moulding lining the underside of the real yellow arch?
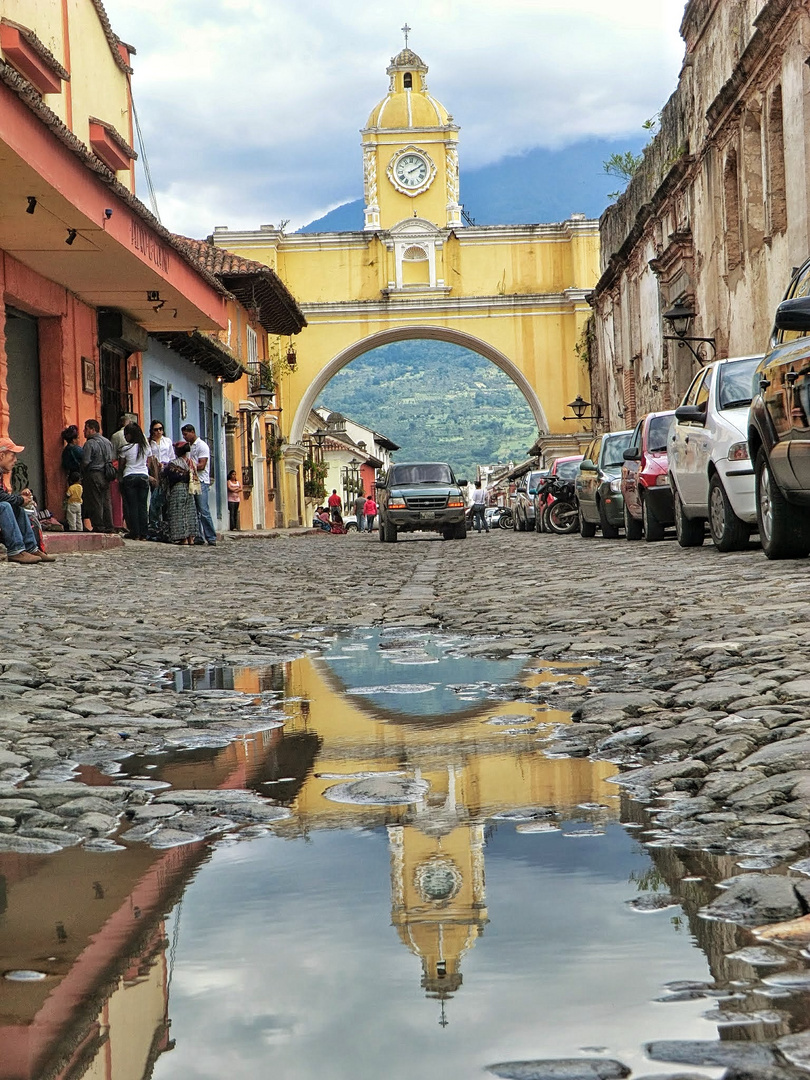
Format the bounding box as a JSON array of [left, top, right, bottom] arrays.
[[289, 325, 549, 443]]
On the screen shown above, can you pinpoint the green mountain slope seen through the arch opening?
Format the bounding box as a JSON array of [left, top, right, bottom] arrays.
[[318, 340, 537, 478]]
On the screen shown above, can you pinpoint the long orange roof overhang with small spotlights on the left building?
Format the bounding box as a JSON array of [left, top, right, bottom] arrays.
[[0, 62, 229, 333]]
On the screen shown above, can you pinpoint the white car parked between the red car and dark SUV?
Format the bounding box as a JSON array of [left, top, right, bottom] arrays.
[[669, 356, 762, 551]]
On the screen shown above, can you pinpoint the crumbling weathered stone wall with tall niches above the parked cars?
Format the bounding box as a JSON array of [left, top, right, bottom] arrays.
[[591, 0, 810, 429]]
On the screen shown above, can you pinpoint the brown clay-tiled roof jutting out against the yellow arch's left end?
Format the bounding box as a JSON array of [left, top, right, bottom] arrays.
[[175, 237, 307, 335]]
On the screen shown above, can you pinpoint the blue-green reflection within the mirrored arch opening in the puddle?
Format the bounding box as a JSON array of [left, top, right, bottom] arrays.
[[322, 630, 526, 717]]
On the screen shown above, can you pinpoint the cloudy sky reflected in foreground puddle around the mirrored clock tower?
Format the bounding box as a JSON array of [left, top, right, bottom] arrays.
[[154, 822, 717, 1080]]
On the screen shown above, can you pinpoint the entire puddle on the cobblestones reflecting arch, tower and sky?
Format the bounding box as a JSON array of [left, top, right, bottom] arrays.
[[6, 630, 810, 1080]]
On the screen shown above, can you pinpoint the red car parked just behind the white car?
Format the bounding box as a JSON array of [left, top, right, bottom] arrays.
[[622, 409, 675, 541]]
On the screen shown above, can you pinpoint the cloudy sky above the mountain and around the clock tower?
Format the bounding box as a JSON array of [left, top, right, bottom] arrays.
[[98, 0, 684, 235]]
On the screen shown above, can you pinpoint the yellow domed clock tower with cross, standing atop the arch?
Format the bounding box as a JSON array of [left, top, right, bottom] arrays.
[[363, 42, 461, 231]]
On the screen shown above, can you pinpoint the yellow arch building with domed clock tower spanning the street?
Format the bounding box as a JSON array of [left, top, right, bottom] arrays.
[[213, 48, 598, 525]]
